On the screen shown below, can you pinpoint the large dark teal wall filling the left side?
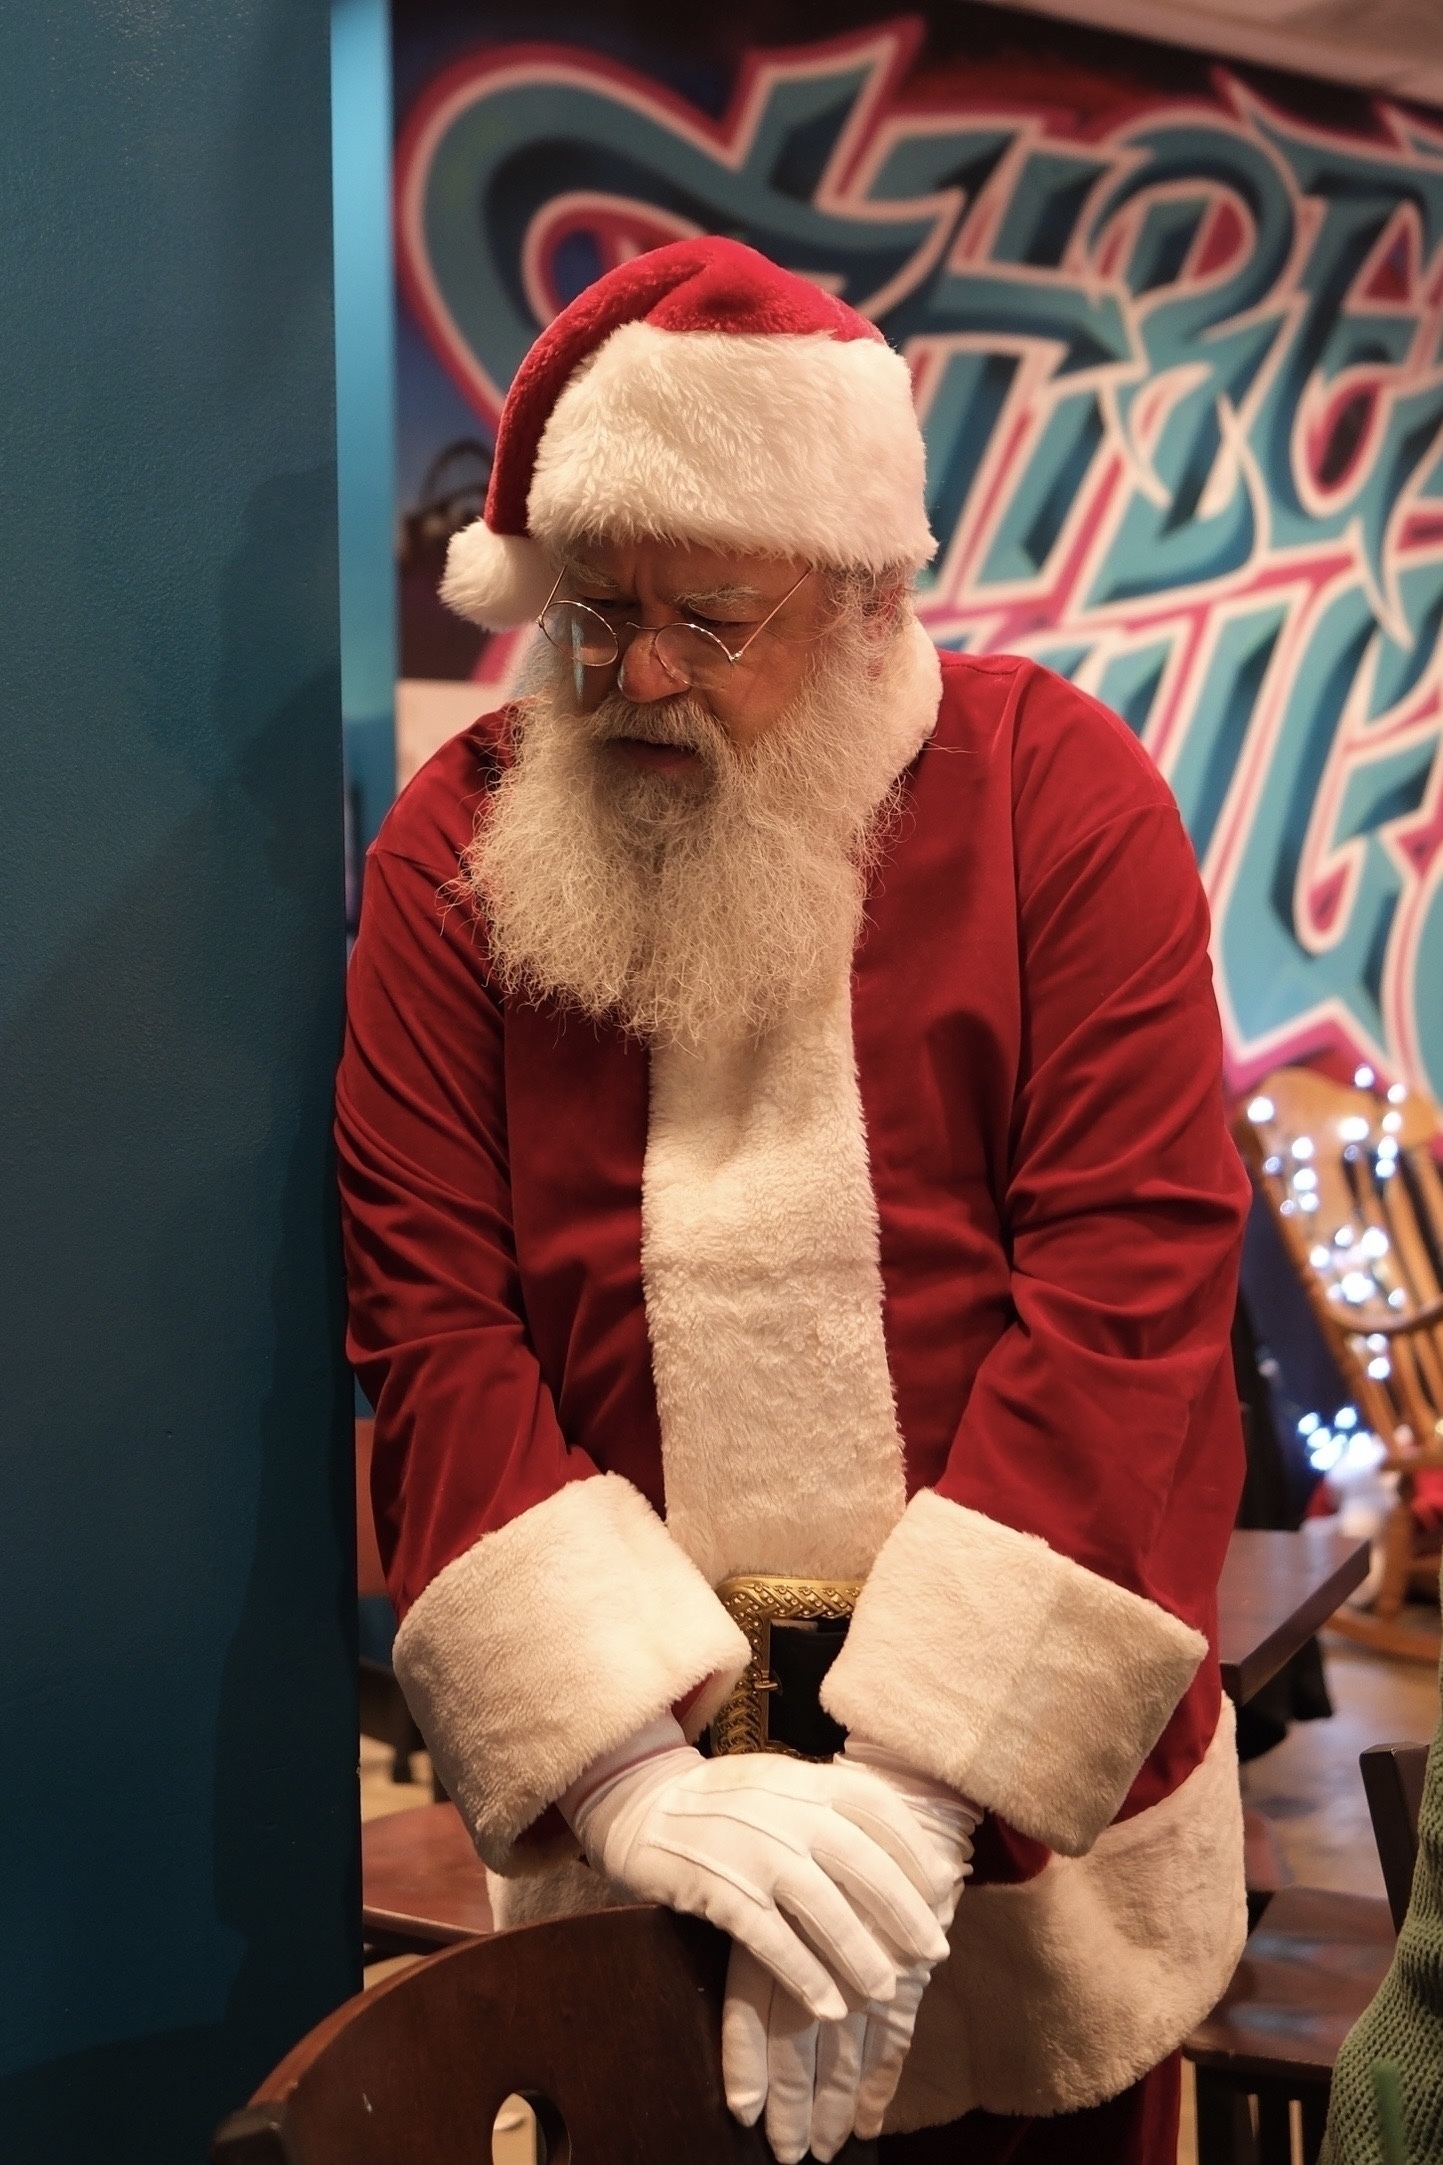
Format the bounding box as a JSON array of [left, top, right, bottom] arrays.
[[0, 0, 359, 2165]]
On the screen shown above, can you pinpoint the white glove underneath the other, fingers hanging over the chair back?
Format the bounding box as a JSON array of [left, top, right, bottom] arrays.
[[723, 1738, 982, 2165]]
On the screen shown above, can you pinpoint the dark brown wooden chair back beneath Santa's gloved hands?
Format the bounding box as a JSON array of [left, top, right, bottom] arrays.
[[210, 1907, 791, 2165]]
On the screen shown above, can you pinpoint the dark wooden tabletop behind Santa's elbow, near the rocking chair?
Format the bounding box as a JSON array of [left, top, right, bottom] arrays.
[[1218, 1520, 1367, 1706]]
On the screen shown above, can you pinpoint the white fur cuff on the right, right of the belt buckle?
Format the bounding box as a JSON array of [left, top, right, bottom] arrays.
[[822, 1490, 1207, 1858]]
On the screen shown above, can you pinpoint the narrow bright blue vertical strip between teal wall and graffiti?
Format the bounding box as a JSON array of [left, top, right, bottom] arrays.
[[331, 0, 396, 847]]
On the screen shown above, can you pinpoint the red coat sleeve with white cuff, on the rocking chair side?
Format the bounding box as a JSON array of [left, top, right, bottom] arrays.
[[824, 678, 1248, 1855]]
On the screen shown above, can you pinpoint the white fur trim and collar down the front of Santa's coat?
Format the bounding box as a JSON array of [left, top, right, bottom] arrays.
[[640, 624, 941, 1585]]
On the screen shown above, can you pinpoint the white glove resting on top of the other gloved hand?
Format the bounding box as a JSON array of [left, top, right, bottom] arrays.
[[558, 1717, 948, 2020]]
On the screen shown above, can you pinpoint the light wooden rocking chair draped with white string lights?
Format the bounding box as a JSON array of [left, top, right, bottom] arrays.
[[1235, 1067, 1443, 1665]]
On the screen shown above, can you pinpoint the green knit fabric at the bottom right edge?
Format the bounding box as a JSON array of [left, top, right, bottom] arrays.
[[1318, 1636, 1443, 2165]]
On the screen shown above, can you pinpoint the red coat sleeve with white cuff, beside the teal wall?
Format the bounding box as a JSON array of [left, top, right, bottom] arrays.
[[337, 814, 746, 1871]]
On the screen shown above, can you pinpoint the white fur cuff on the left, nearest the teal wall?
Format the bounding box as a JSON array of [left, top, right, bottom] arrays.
[[396, 1474, 749, 1873]]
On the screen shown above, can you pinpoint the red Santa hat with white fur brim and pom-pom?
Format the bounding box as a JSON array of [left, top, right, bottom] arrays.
[[441, 238, 937, 630]]
